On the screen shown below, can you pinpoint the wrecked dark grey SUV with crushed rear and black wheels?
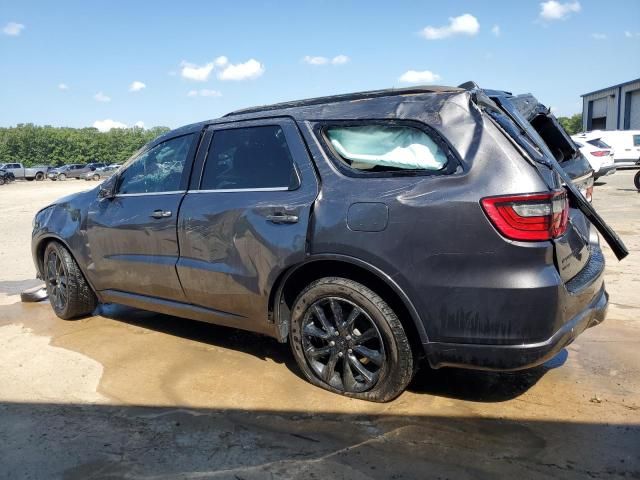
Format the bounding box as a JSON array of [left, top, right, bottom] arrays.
[[32, 86, 626, 401]]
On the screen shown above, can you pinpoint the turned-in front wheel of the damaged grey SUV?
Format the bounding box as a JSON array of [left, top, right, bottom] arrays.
[[42, 242, 98, 320]]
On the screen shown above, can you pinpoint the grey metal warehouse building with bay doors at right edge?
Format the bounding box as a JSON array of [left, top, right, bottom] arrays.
[[582, 78, 640, 131]]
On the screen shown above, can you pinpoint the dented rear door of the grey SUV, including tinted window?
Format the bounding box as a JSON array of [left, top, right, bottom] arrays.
[[177, 118, 318, 330]]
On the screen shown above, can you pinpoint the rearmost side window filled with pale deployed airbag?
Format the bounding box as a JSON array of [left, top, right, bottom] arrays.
[[326, 125, 448, 172]]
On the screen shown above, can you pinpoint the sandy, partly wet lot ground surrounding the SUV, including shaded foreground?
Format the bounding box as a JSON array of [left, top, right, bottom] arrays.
[[0, 171, 640, 479]]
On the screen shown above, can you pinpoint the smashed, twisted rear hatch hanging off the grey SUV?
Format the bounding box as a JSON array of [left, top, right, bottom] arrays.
[[464, 85, 628, 281]]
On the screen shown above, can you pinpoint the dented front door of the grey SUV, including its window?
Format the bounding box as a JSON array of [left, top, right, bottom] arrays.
[[87, 134, 197, 301]]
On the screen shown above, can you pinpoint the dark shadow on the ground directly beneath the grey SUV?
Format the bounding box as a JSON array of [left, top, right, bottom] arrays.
[[96, 304, 567, 402]]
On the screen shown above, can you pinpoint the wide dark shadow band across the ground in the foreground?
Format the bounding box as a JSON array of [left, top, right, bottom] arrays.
[[0, 401, 640, 480]]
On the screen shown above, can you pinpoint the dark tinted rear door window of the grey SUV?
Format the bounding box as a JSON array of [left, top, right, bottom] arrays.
[[200, 125, 298, 190]]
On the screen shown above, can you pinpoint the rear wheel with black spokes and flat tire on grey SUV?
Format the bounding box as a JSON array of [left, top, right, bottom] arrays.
[[289, 277, 414, 402]]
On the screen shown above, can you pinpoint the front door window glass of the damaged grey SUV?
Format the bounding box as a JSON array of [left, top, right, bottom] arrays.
[[117, 134, 194, 194]]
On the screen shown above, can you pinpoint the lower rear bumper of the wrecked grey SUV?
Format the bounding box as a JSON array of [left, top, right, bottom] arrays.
[[425, 285, 609, 370]]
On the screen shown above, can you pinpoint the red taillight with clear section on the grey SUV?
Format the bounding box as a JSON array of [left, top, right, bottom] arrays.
[[481, 190, 569, 241]]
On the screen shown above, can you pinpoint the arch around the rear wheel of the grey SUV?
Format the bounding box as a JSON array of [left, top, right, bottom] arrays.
[[269, 254, 428, 355]]
